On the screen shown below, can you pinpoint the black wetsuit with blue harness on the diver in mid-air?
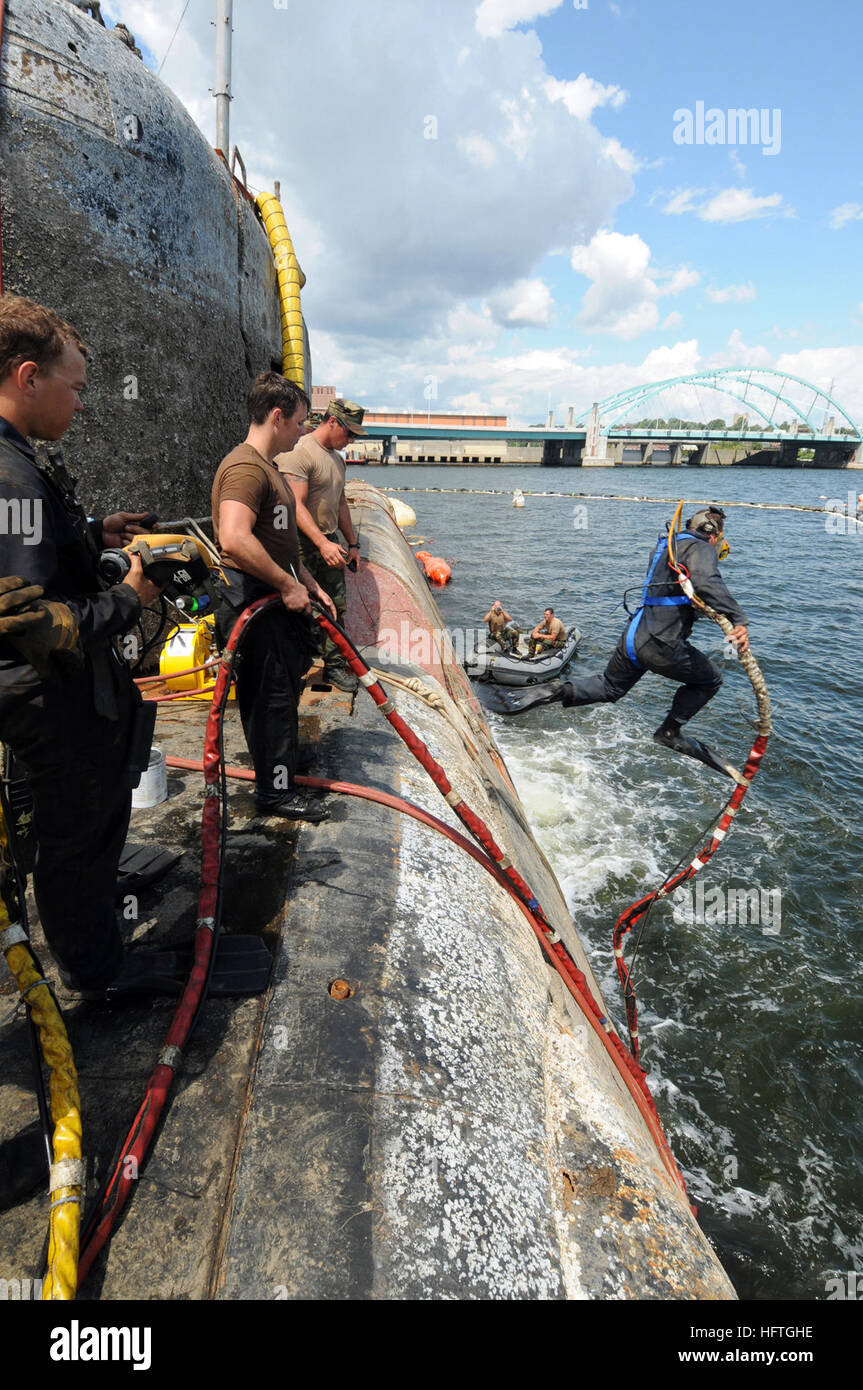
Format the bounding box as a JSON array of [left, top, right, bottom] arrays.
[[561, 531, 746, 724]]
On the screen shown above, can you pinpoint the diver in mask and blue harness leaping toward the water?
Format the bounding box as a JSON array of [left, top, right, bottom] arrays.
[[500, 506, 749, 773]]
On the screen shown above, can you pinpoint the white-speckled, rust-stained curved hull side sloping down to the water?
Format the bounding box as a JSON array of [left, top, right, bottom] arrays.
[[218, 484, 734, 1298]]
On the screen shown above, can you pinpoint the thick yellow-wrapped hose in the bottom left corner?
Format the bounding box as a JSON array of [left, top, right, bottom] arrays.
[[0, 810, 83, 1301]]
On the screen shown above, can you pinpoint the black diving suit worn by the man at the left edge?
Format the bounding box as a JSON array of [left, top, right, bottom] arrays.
[[0, 420, 142, 988]]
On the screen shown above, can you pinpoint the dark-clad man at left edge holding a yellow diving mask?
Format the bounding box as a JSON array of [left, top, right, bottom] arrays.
[[0, 295, 158, 991]]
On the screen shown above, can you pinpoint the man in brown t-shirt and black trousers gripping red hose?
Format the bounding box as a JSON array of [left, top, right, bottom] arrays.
[[213, 371, 335, 823]]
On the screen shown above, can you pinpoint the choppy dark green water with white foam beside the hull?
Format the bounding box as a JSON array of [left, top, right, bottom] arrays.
[[350, 467, 863, 1300]]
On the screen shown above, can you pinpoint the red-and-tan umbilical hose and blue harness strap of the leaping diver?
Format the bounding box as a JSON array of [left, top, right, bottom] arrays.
[[613, 502, 770, 1062]]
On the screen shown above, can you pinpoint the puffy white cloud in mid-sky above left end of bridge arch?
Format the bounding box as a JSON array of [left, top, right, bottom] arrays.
[[570, 231, 700, 339]]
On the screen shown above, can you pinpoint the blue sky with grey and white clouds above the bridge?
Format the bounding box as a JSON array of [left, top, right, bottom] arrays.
[[103, 0, 863, 423]]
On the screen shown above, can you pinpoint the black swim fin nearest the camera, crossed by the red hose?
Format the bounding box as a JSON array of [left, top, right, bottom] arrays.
[[81, 935, 272, 1001]]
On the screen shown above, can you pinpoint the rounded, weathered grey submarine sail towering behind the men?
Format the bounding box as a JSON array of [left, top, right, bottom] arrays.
[[0, 0, 310, 516]]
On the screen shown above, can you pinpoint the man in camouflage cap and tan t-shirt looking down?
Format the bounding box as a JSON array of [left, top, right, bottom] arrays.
[[275, 399, 365, 691]]
